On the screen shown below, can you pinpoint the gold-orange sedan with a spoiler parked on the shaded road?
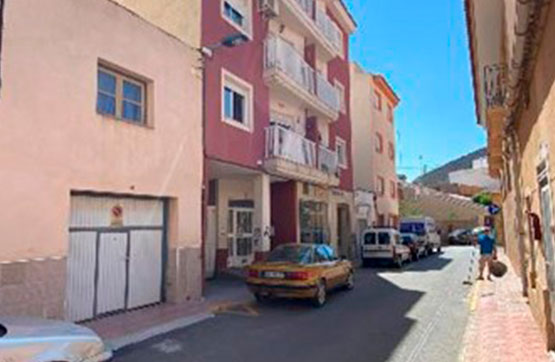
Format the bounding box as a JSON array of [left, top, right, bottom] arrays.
[[247, 244, 354, 307]]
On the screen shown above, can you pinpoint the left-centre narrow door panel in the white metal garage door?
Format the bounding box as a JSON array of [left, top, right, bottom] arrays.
[[96, 232, 128, 315]]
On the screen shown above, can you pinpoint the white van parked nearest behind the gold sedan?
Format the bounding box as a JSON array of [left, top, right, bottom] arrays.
[[361, 228, 411, 267]]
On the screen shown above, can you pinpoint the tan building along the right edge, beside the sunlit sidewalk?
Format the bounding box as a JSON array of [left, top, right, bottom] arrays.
[[466, 0, 555, 349]]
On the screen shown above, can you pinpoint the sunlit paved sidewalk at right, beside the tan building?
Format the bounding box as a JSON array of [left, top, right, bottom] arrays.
[[461, 251, 550, 362]]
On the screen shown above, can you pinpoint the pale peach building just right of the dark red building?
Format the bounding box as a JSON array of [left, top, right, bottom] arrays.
[[350, 63, 399, 235]]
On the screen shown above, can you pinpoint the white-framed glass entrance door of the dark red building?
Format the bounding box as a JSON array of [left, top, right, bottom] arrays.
[[228, 207, 254, 267]]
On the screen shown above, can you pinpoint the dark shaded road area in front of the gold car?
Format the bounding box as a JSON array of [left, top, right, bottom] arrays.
[[114, 270, 424, 362]]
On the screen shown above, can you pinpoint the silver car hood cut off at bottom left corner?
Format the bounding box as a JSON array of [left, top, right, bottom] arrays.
[[0, 317, 112, 362]]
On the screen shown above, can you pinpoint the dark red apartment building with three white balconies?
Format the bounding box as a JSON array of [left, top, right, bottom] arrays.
[[202, 0, 355, 276]]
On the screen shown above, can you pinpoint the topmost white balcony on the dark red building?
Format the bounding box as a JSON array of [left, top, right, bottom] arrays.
[[279, 0, 344, 62]]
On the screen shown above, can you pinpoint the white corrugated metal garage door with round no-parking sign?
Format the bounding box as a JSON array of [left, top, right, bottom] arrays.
[[66, 195, 166, 321]]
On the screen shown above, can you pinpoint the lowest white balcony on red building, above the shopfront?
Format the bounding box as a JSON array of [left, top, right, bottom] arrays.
[[264, 125, 339, 186]]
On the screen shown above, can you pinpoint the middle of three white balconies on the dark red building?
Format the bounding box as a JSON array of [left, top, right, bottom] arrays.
[[264, 36, 340, 121]]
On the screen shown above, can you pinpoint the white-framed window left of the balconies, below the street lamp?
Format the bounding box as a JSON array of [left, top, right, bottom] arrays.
[[222, 70, 253, 132]]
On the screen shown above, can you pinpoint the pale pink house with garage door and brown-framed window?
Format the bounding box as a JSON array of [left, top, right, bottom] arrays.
[[0, 0, 203, 321]]
